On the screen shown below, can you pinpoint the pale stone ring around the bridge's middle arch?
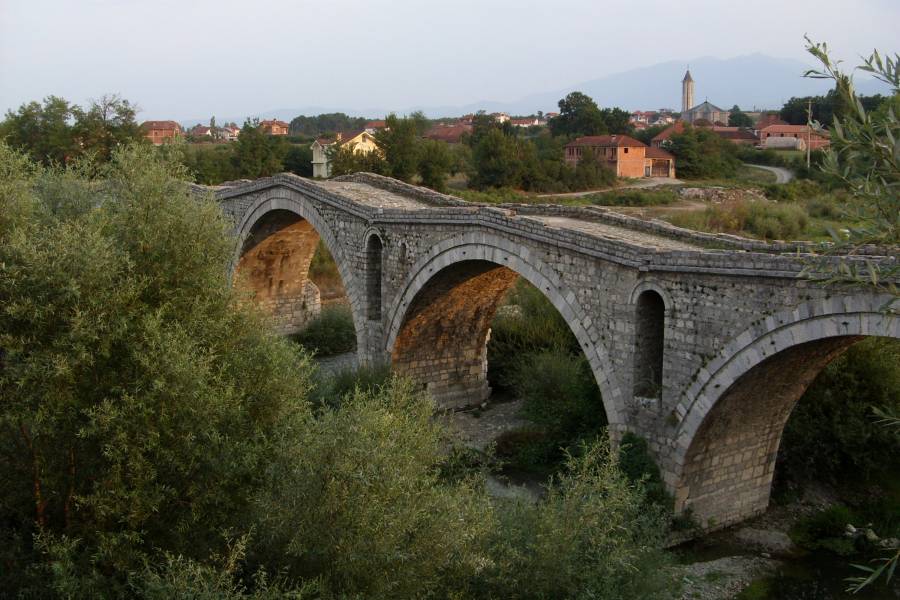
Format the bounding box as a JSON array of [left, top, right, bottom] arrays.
[[385, 233, 625, 432]]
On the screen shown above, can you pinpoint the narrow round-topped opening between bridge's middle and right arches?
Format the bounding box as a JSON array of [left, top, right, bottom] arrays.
[[633, 290, 666, 398]]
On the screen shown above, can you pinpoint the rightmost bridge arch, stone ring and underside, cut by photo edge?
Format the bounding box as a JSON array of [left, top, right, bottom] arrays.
[[667, 294, 900, 527]]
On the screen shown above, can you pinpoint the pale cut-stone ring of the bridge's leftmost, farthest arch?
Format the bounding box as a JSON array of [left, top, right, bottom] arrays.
[[229, 187, 364, 349]]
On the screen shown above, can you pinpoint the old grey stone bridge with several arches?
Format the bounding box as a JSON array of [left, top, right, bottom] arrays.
[[211, 174, 900, 527]]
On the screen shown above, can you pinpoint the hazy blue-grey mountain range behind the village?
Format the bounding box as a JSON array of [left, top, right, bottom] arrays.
[[181, 54, 888, 126]]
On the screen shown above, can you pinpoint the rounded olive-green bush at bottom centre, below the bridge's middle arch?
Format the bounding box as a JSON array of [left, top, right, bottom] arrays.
[[251, 380, 493, 598]]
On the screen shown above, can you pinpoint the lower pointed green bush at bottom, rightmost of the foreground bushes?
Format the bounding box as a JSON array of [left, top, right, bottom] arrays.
[[474, 441, 675, 600]]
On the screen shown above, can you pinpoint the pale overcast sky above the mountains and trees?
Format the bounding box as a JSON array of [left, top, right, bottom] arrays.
[[0, 0, 900, 119]]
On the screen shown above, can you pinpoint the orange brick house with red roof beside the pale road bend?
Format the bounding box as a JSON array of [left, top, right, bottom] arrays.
[[565, 135, 675, 178]]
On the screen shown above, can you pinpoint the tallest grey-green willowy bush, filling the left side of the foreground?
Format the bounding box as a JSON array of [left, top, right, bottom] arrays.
[[0, 144, 312, 595]]
